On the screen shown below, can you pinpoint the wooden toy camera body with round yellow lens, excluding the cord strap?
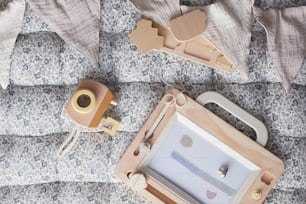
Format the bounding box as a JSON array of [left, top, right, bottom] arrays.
[[66, 80, 119, 129]]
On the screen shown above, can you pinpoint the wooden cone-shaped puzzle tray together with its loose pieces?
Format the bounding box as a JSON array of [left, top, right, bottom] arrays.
[[130, 10, 235, 72]]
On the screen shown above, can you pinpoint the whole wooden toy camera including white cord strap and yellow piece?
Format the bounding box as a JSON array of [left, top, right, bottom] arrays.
[[58, 80, 120, 156]]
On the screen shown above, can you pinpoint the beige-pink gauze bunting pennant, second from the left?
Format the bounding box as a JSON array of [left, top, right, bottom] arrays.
[[27, 0, 100, 67]]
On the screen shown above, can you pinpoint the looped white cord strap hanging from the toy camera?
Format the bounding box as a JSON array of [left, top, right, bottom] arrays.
[[57, 125, 80, 157]]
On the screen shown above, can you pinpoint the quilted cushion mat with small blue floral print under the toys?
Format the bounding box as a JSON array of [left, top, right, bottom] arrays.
[[0, 0, 306, 204]]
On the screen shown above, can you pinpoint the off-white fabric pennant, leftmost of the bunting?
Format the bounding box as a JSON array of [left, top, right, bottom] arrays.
[[0, 0, 25, 89]]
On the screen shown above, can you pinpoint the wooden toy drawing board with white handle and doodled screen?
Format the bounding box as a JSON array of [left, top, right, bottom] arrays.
[[115, 89, 284, 204]]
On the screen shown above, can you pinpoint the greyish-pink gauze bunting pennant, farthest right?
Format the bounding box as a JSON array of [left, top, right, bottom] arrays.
[[253, 6, 306, 90]]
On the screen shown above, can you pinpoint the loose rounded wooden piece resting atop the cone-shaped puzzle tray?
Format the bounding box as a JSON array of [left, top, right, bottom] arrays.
[[169, 10, 206, 42]]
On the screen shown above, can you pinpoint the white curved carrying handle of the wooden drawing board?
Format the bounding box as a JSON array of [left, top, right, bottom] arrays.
[[196, 91, 268, 146]]
